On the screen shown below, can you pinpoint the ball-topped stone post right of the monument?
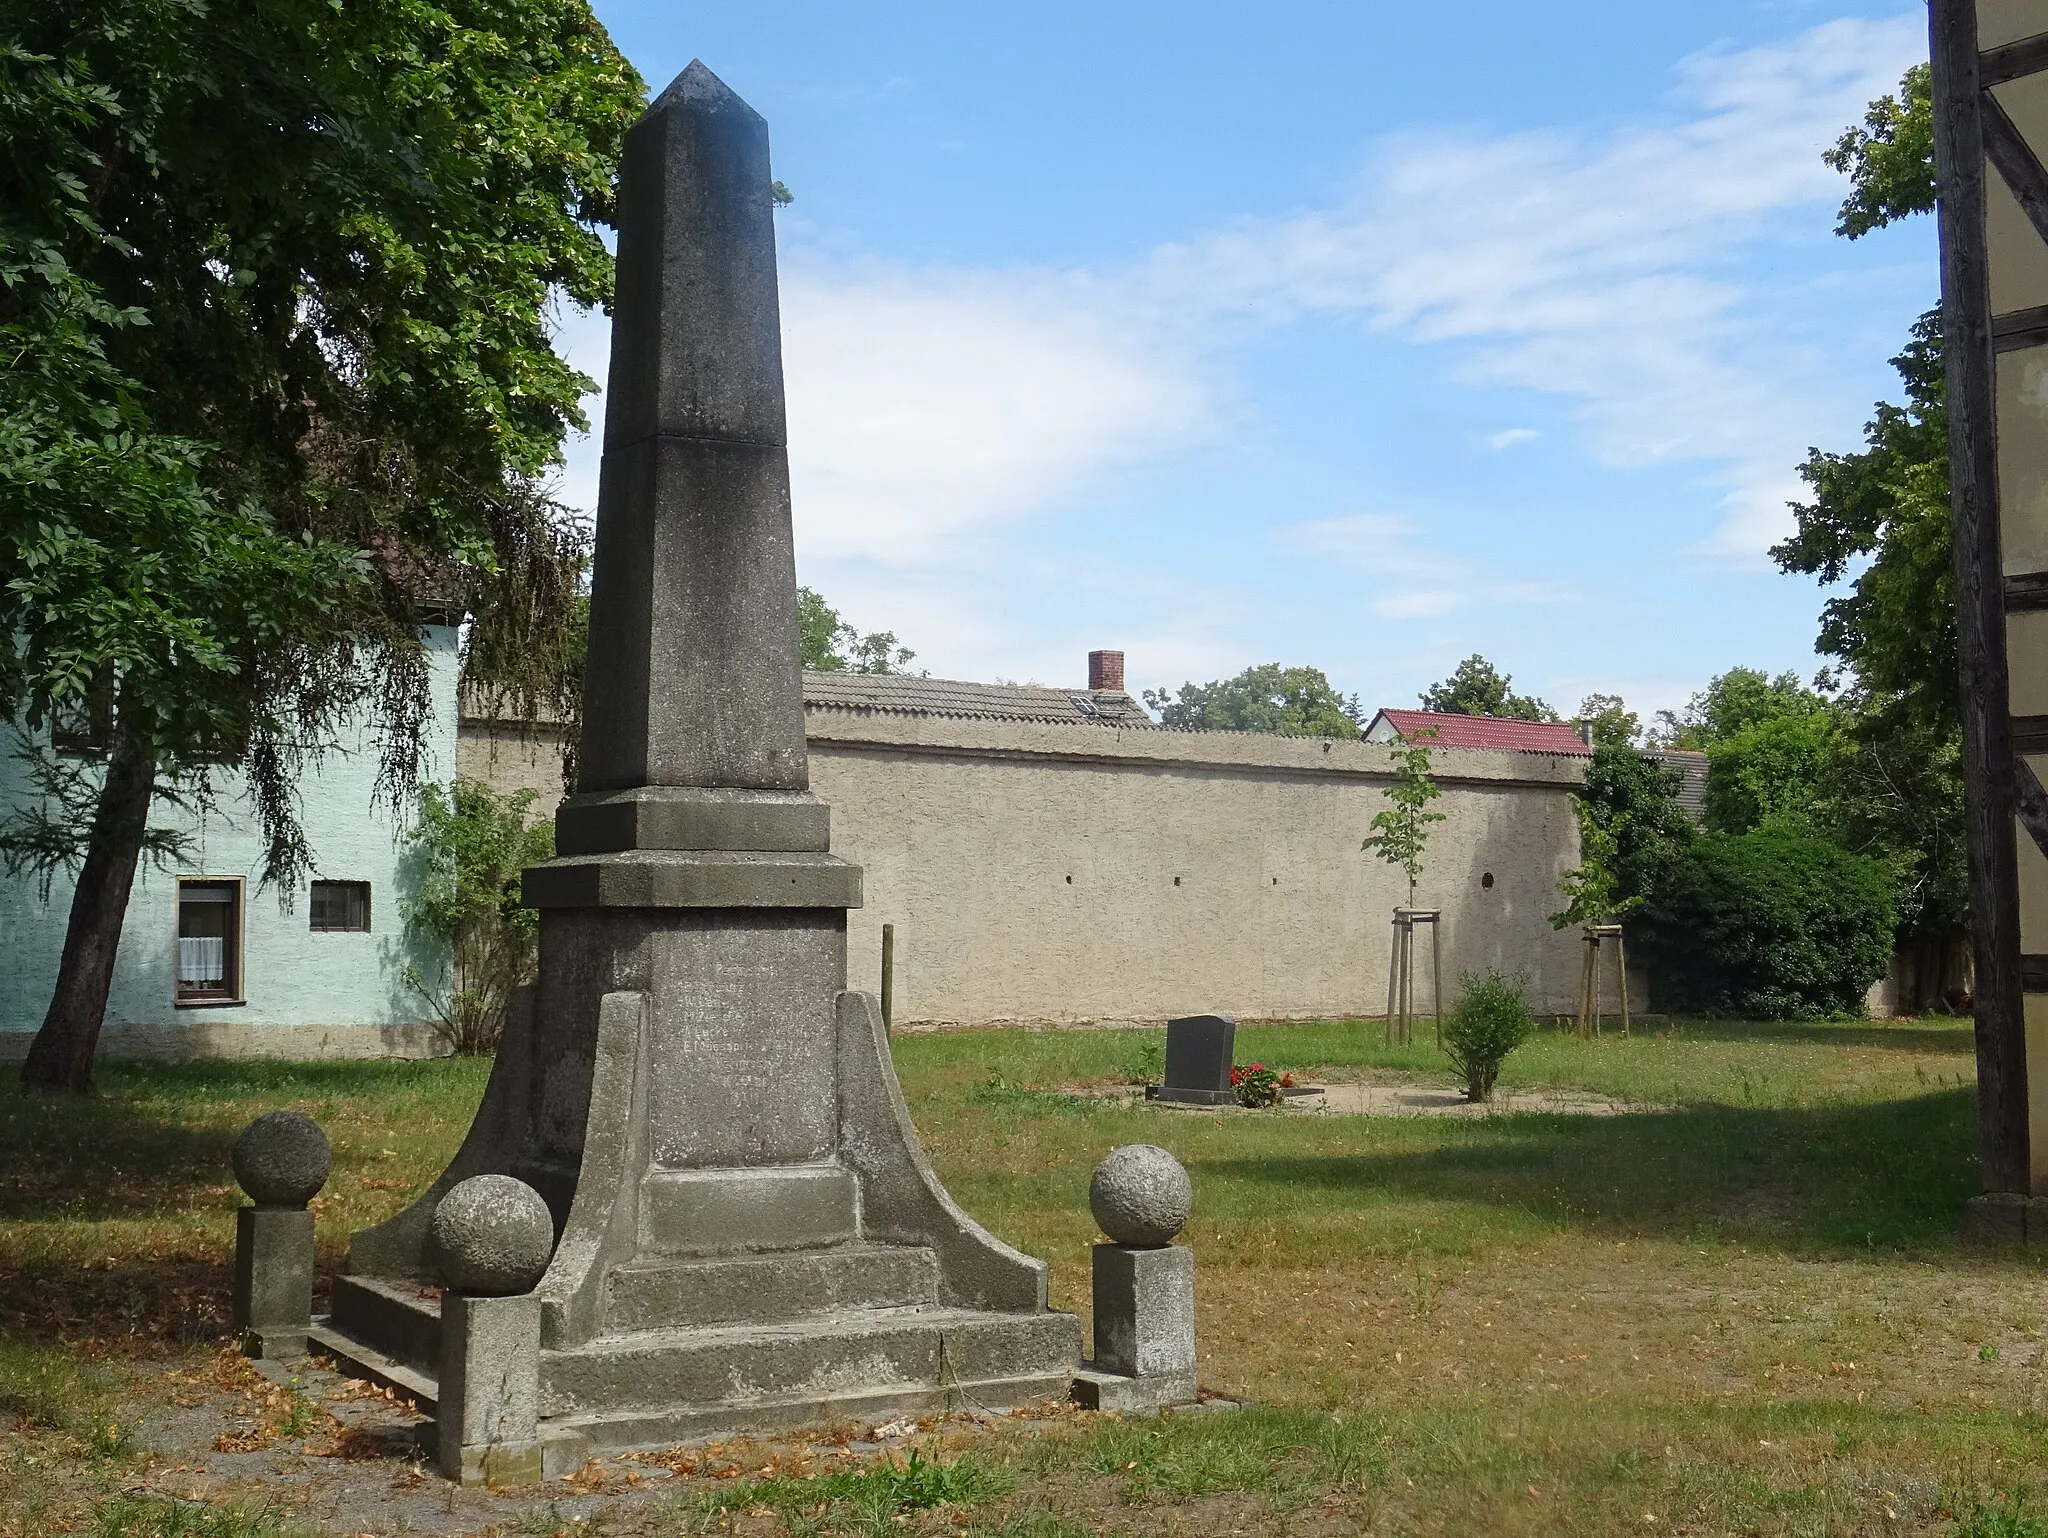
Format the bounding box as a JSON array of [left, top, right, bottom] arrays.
[[1073, 1143, 1196, 1409]]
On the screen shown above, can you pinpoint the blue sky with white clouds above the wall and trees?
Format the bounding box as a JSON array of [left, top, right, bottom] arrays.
[[563, 0, 1937, 717]]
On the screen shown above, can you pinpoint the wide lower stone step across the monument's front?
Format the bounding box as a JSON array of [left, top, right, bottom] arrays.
[[541, 1307, 1079, 1427]]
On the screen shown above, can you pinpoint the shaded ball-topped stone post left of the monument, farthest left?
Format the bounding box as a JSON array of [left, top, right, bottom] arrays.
[[233, 1110, 334, 1360]]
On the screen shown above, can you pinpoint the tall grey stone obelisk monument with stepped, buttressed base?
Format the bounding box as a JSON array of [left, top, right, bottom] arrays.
[[315, 63, 1079, 1468]]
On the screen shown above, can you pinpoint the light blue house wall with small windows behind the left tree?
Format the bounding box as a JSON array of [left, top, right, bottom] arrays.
[[0, 627, 457, 1059]]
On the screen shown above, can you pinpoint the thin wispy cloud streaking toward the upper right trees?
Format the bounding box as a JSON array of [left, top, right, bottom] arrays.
[[1147, 14, 1925, 559]]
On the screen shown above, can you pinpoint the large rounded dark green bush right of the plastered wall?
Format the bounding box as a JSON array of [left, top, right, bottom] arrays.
[[1632, 827, 1892, 1020]]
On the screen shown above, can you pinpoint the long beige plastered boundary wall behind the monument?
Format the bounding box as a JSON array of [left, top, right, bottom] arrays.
[[459, 709, 1597, 1026]]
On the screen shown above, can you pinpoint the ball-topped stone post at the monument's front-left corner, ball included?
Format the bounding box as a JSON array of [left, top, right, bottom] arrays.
[[428, 1176, 555, 1487]]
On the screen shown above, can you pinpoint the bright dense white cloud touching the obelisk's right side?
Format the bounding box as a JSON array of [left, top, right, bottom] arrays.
[[782, 258, 1212, 563]]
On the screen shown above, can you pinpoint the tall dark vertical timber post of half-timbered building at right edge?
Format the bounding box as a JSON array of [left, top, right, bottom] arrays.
[[1927, 0, 2048, 1194]]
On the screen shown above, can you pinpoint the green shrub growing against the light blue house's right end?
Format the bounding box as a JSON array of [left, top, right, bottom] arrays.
[[401, 778, 555, 1053]]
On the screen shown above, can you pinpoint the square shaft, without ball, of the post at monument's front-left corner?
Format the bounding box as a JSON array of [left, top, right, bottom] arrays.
[[434, 1294, 543, 1485]]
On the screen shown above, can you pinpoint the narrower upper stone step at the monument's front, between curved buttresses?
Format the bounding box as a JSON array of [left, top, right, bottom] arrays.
[[604, 1243, 938, 1335]]
